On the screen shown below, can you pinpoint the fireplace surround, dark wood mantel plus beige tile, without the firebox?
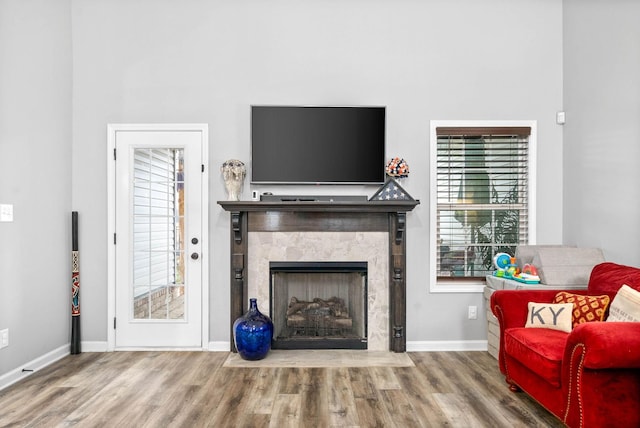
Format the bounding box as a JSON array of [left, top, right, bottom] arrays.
[[218, 201, 418, 352]]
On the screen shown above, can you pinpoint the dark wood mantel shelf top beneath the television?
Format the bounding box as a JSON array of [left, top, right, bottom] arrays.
[[218, 201, 420, 213]]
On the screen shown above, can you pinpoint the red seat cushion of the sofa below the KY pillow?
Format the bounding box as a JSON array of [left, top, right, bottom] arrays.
[[504, 327, 569, 388]]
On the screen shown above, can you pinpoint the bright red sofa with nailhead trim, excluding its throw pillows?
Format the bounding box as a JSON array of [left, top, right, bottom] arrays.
[[490, 262, 640, 428]]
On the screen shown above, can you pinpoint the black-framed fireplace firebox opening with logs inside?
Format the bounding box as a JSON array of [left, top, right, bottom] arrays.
[[269, 262, 367, 349]]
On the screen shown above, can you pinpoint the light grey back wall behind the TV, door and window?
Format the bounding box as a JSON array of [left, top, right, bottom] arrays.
[[72, 0, 563, 341]]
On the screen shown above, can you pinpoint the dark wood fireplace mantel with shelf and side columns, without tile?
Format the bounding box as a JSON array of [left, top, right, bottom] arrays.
[[218, 201, 420, 352]]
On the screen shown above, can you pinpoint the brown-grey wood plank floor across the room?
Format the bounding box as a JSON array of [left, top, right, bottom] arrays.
[[0, 352, 562, 428]]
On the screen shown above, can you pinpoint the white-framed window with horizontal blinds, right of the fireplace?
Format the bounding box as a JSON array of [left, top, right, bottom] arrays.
[[431, 121, 535, 292]]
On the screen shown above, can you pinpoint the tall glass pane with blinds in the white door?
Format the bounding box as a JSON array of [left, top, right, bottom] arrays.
[[131, 149, 185, 320]]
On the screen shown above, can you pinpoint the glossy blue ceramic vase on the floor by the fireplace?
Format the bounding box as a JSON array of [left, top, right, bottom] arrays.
[[233, 299, 273, 360]]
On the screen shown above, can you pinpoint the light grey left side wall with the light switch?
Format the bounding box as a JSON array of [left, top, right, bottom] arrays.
[[0, 0, 72, 378]]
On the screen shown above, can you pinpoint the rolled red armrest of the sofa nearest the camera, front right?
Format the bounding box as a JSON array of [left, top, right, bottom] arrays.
[[563, 322, 640, 369]]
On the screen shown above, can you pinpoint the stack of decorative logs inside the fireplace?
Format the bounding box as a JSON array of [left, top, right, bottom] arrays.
[[287, 296, 353, 337]]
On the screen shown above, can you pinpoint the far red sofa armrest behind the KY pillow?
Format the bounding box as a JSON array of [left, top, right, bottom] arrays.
[[490, 290, 560, 330]]
